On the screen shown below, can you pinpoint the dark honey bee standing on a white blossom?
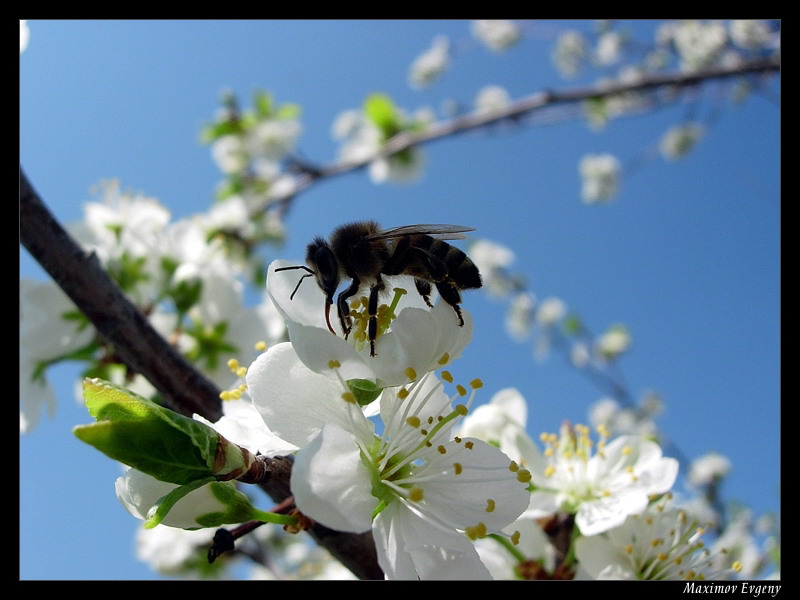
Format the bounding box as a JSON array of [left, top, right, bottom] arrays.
[[275, 221, 481, 356]]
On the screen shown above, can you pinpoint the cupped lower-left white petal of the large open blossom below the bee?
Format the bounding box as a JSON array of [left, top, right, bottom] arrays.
[[291, 424, 377, 533]]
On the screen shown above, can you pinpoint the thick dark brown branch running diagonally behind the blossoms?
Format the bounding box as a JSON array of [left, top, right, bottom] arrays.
[[19, 168, 383, 579]]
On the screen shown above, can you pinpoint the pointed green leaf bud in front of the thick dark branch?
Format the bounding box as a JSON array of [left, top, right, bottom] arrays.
[[73, 379, 219, 485]]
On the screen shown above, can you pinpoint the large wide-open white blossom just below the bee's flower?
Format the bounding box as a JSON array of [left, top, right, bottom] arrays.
[[247, 354, 528, 579]]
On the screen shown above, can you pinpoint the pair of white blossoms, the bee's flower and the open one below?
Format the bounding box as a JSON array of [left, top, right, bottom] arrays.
[[246, 262, 529, 579]]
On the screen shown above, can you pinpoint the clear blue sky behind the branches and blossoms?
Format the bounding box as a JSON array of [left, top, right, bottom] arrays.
[[20, 20, 781, 579]]
